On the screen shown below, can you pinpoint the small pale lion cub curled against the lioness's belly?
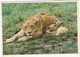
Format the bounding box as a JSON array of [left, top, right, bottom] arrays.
[[46, 24, 68, 36]]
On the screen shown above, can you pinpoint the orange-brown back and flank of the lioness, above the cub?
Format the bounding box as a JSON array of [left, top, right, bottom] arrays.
[[38, 12, 59, 28]]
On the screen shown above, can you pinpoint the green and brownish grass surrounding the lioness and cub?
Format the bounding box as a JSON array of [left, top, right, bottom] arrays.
[[2, 2, 78, 55]]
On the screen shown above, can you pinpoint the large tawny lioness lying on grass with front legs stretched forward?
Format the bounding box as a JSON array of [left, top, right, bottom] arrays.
[[6, 12, 61, 43]]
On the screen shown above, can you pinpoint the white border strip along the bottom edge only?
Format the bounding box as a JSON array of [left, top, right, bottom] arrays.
[[3, 54, 79, 57]]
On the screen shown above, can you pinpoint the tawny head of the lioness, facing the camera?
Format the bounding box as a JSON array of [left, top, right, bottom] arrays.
[[19, 16, 42, 38]]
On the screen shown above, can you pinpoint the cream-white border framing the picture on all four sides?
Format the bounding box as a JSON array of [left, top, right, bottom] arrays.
[[0, 0, 80, 57]]
